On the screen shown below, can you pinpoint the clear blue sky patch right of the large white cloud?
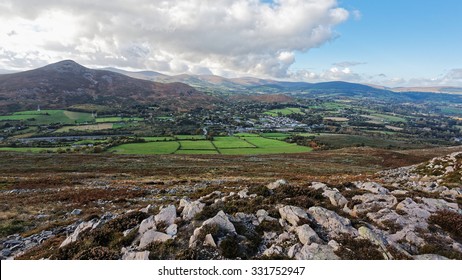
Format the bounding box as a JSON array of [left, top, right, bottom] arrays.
[[292, 0, 462, 83]]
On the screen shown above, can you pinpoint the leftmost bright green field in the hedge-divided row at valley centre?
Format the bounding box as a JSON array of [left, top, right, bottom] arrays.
[[109, 142, 180, 155]]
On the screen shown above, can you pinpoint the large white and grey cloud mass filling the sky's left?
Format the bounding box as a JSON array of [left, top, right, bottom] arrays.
[[0, 0, 349, 77]]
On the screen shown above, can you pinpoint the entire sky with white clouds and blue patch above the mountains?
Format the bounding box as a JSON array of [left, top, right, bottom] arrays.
[[0, 0, 462, 87]]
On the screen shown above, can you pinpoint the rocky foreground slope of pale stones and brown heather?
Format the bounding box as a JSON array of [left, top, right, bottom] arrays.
[[1, 152, 462, 260]]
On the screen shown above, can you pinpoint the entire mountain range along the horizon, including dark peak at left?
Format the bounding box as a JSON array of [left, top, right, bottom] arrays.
[[0, 60, 462, 113]]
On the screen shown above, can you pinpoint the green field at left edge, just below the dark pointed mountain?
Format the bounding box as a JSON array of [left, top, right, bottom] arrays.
[[0, 110, 94, 125]]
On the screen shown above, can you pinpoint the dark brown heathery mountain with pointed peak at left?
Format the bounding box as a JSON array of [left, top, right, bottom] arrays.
[[0, 60, 217, 113]]
